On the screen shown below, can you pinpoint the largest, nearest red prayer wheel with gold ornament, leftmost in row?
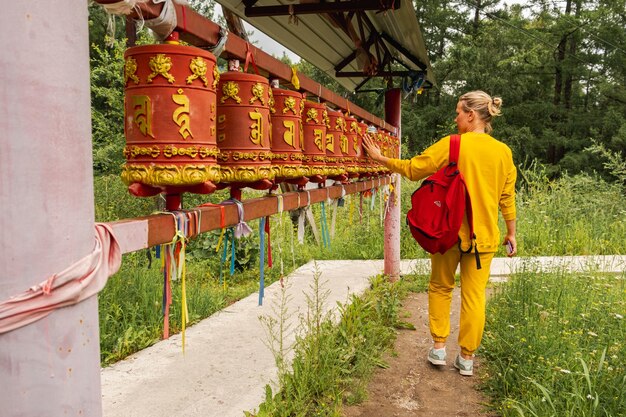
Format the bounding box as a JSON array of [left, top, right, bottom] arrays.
[[121, 43, 220, 196]]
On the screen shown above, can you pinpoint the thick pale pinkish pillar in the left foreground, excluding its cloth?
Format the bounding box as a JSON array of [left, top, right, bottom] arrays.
[[0, 0, 102, 417]]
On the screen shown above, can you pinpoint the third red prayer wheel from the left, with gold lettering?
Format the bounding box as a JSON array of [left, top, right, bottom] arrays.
[[270, 88, 306, 181]]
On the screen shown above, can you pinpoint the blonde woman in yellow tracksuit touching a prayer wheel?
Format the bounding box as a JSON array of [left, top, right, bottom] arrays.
[[364, 91, 517, 375]]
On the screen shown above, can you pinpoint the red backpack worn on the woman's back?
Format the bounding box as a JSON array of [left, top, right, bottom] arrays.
[[406, 135, 480, 269]]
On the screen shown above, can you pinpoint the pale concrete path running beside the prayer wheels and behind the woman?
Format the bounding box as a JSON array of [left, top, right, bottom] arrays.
[[102, 256, 626, 417]]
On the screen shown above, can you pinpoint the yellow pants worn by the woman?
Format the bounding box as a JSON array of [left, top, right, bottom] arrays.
[[428, 247, 494, 355]]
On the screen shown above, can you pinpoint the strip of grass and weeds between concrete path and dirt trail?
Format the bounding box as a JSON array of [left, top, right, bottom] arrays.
[[251, 271, 400, 417]]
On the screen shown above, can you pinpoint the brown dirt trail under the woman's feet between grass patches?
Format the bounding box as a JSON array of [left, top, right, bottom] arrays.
[[344, 288, 494, 417]]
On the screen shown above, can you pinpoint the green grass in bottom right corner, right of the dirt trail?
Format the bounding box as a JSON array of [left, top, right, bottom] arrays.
[[480, 270, 626, 417]]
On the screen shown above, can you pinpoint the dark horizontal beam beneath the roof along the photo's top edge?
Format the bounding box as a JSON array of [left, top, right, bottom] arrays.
[[245, 0, 401, 17]]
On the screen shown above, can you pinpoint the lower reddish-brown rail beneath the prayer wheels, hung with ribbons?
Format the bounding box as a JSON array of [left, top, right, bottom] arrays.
[[108, 176, 391, 253]]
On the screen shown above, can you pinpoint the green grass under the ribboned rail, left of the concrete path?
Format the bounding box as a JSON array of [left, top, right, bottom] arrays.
[[98, 251, 243, 365]]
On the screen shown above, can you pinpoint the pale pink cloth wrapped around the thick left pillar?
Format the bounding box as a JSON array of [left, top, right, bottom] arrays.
[[0, 224, 122, 334]]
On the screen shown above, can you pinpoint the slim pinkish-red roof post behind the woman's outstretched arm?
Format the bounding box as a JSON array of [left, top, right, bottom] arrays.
[[384, 88, 402, 281]]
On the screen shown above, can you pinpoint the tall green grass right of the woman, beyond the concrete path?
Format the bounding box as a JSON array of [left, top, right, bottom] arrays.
[[512, 167, 626, 256]]
